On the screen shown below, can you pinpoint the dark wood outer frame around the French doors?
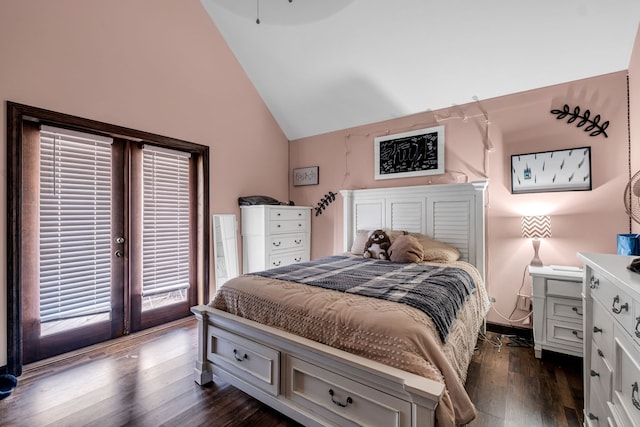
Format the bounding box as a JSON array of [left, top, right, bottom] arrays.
[[7, 101, 210, 376]]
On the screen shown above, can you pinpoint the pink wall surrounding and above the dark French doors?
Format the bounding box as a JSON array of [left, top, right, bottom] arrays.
[[0, 0, 288, 366]]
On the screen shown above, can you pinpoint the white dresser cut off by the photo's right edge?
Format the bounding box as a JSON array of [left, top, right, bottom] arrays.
[[578, 253, 640, 427]]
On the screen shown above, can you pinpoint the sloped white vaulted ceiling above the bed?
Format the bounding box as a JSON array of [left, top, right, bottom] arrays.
[[201, 0, 640, 140]]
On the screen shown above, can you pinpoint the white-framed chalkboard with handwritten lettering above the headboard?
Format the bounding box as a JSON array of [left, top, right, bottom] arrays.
[[374, 126, 444, 179]]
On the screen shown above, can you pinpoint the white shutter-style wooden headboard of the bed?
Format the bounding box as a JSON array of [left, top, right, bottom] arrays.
[[340, 181, 488, 279]]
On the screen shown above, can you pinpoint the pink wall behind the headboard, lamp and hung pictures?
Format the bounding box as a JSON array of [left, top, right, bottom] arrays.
[[290, 72, 629, 326]]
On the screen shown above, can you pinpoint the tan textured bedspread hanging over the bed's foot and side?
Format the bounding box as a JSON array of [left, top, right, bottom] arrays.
[[210, 261, 489, 427]]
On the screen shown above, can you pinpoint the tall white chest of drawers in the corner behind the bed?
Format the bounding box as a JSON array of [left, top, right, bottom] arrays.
[[240, 205, 311, 273]]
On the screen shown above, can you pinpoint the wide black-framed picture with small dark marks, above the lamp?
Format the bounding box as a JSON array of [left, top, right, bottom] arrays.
[[511, 147, 591, 194]]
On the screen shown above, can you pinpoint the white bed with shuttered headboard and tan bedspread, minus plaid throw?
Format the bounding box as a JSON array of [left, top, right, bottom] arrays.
[[192, 182, 488, 427]]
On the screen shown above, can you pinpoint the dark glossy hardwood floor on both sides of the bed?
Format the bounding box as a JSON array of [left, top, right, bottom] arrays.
[[0, 318, 582, 427]]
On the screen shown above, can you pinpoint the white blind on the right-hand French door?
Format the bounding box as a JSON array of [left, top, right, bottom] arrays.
[[142, 146, 190, 297]]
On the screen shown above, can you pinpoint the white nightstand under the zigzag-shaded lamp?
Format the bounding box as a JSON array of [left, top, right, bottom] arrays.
[[529, 266, 584, 359]]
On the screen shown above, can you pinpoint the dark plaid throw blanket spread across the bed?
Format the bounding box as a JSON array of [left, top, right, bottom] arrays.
[[251, 256, 475, 342]]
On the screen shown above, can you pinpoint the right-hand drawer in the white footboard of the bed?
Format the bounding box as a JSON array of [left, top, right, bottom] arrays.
[[285, 356, 411, 427]]
